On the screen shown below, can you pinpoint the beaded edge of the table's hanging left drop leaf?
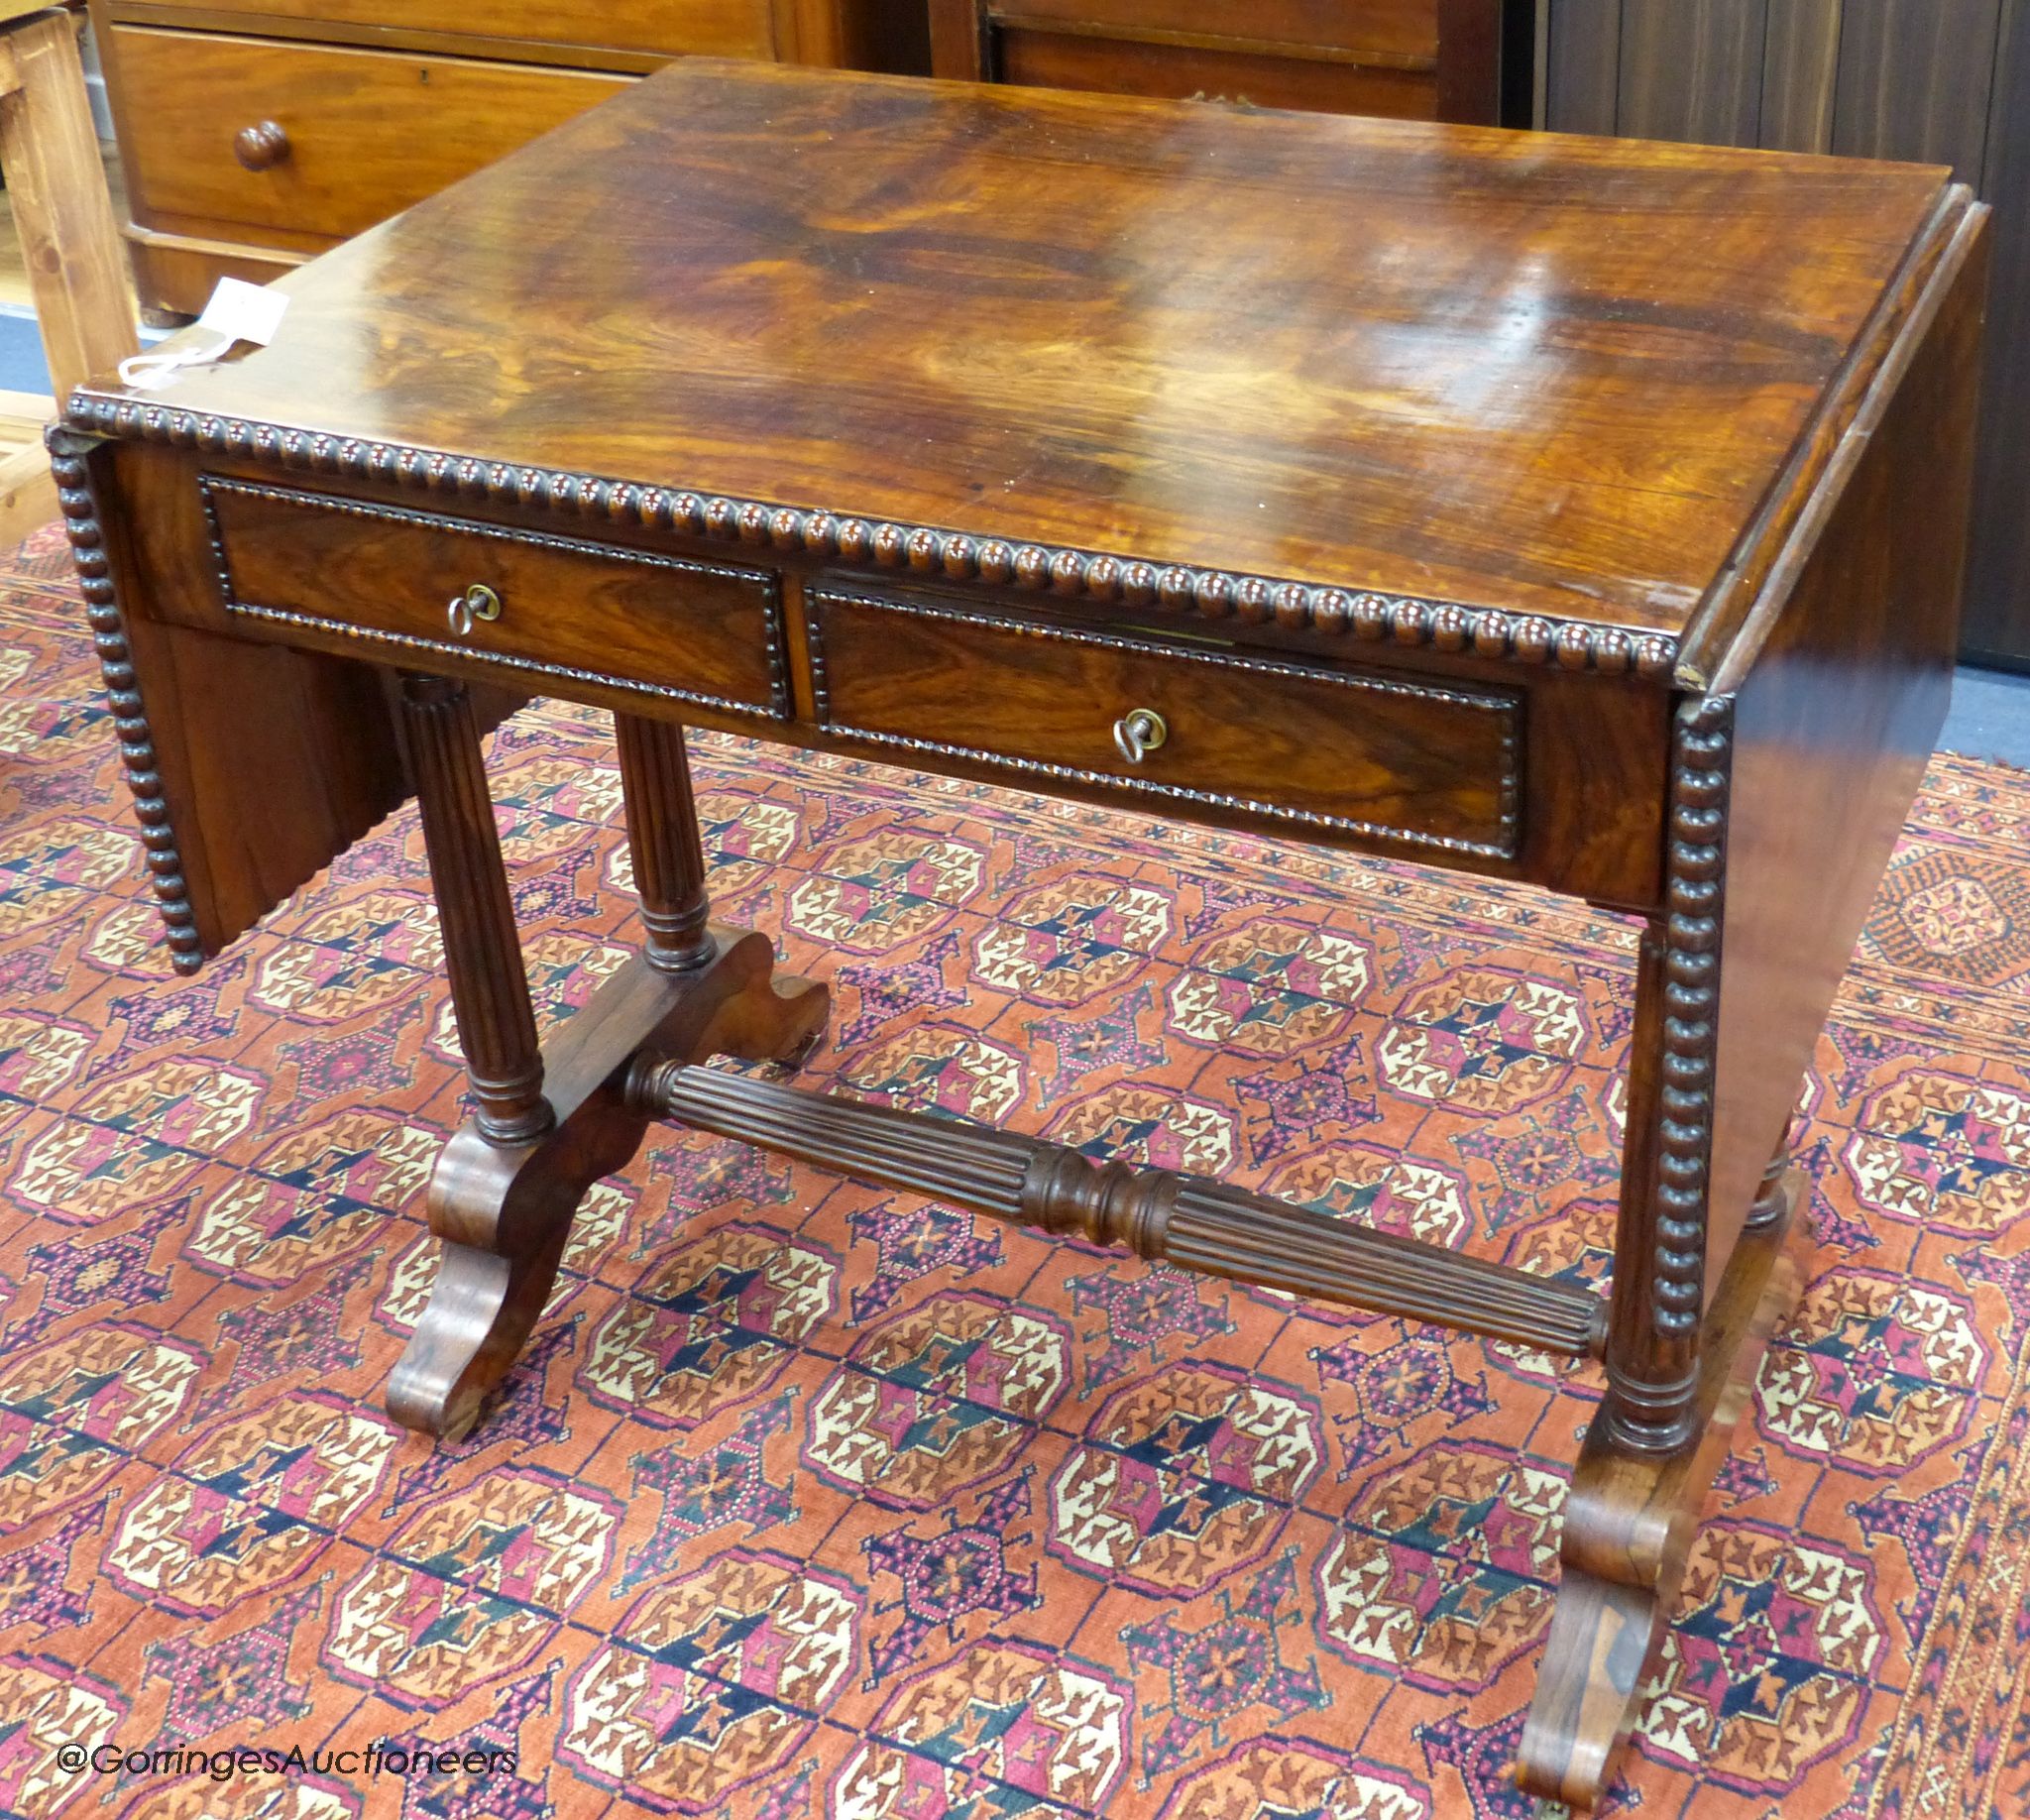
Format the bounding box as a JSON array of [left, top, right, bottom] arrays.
[[43, 424, 205, 973]]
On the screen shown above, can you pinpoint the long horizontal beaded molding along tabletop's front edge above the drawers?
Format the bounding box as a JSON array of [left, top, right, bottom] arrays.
[[62, 392, 1679, 683]]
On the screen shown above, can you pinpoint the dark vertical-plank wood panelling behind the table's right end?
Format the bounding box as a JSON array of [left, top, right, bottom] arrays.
[[1545, 0, 2030, 668]]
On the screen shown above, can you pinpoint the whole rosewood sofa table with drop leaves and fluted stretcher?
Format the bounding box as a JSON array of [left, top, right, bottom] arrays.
[[53, 60, 1985, 1806]]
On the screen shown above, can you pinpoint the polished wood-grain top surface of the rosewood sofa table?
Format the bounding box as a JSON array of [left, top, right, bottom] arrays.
[[78, 58, 1947, 635]]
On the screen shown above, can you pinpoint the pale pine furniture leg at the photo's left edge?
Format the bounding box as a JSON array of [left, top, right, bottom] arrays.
[[0, 0, 136, 542]]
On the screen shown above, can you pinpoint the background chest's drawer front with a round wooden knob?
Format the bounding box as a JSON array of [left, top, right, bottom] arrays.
[[112, 27, 629, 238]]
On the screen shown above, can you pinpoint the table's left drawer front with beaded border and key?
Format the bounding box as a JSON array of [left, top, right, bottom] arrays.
[[201, 475, 792, 719]]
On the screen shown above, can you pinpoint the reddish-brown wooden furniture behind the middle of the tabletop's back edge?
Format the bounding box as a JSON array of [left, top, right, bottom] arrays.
[[930, 0, 1528, 126]]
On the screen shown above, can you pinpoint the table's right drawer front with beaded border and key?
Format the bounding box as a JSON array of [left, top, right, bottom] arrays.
[[806, 587, 1522, 859]]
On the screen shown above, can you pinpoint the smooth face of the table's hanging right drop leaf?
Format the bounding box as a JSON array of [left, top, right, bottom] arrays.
[[1709, 198, 1987, 1284]]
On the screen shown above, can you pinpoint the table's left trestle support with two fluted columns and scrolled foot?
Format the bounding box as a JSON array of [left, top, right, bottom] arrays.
[[388, 698, 827, 1436]]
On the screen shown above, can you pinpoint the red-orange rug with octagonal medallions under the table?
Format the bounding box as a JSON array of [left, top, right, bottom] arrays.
[[0, 512, 2030, 1820]]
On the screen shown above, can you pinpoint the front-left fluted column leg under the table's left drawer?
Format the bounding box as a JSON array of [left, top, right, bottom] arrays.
[[402, 676, 554, 1144]]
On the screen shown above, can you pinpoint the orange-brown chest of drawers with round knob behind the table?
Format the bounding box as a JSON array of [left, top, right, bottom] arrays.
[[91, 0, 928, 315]]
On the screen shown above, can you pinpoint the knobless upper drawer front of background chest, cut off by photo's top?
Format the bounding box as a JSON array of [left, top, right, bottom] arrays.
[[126, 0, 775, 57]]
